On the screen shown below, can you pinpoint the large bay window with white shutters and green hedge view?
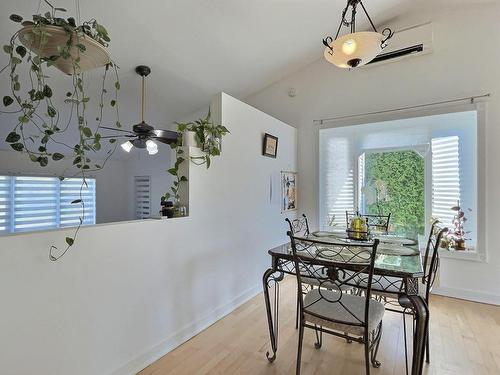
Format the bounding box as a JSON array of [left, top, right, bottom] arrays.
[[319, 110, 484, 257]]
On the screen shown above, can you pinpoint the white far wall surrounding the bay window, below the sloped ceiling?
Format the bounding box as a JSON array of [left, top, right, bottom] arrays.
[[246, 3, 500, 303]]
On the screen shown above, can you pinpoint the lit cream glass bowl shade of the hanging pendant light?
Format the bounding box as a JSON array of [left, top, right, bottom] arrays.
[[325, 31, 386, 68]]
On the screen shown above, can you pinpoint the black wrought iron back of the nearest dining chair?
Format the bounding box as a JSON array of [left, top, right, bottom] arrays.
[[287, 235, 379, 339]]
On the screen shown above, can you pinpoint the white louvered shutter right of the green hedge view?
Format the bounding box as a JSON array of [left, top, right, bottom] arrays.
[[432, 136, 460, 225]]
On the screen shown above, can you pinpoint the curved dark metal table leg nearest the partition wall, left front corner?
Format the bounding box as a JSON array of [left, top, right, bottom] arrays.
[[262, 268, 284, 362]]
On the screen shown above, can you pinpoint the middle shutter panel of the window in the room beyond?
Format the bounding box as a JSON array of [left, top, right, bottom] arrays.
[[12, 176, 59, 232]]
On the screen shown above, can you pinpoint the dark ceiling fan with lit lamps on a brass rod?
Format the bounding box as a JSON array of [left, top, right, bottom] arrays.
[[101, 65, 179, 155]]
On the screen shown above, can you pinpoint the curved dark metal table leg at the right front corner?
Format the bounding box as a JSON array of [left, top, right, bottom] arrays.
[[406, 295, 429, 375]]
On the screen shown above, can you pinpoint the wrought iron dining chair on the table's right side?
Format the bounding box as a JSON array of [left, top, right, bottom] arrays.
[[358, 220, 448, 373]]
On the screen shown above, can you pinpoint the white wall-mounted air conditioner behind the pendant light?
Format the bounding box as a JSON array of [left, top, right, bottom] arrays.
[[364, 22, 433, 67]]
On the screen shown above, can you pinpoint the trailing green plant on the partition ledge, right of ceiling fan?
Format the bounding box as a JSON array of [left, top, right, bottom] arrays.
[[163, 109, 229, 208]]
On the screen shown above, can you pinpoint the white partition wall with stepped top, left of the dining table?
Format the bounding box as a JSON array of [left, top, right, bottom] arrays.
[[0, 94, 297, 375]]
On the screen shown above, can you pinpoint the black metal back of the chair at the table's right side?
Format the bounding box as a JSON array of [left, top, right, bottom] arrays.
[[422, 220, 448, 301]]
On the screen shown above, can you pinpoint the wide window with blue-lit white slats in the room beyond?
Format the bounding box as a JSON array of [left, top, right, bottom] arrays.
[[0, 176, 96, 234]]
